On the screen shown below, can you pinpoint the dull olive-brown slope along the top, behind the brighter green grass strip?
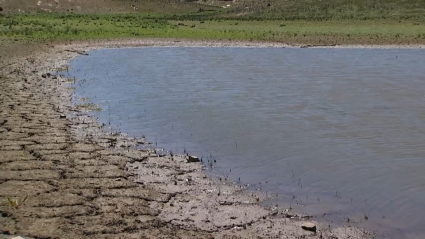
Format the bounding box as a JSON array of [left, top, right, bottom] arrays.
[[0, 0, 425, 21]]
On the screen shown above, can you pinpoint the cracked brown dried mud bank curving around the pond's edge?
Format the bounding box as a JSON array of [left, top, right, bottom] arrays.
[[0, 39, 374, 239]]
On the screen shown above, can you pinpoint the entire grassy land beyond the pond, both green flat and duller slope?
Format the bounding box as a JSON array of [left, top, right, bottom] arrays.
[[0, 0, 425, 45]]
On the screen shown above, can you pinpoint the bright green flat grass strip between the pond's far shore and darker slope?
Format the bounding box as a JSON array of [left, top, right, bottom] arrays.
[[0, 12, 425, 45]]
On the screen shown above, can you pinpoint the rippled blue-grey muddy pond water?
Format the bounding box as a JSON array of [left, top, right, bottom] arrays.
[[70, 48, 425, 238]]
